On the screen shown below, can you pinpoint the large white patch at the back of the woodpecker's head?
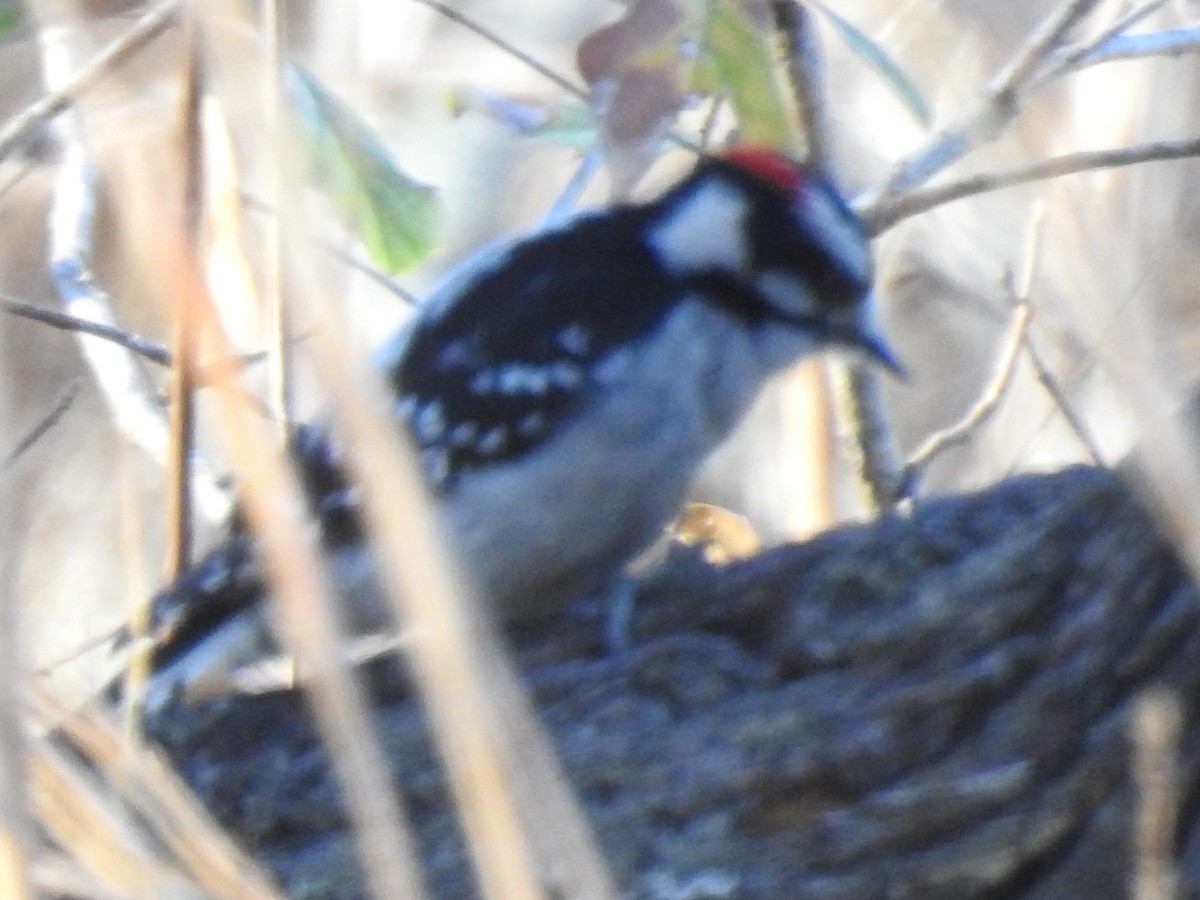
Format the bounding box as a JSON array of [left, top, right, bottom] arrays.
[[649, 181, 750, 276]]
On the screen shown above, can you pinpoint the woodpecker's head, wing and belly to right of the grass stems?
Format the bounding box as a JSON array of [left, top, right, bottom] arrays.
[[136, 150, 896, 705]]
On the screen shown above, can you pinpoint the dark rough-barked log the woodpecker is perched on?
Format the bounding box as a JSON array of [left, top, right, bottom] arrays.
[[151, 468, 1200, 900]]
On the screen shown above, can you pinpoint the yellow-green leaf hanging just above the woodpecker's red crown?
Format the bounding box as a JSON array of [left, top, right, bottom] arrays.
[[704, 0, 800, 154]]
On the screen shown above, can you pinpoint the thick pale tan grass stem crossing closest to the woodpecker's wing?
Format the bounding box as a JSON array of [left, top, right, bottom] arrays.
[[304, 247, 556, 898]]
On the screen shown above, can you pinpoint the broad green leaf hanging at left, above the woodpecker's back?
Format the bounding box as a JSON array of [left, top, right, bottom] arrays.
[[287, 66, 440, 275]]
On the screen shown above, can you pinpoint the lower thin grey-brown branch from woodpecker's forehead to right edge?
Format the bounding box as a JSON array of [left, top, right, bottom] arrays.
[[860, 138, 1200, 236]]
